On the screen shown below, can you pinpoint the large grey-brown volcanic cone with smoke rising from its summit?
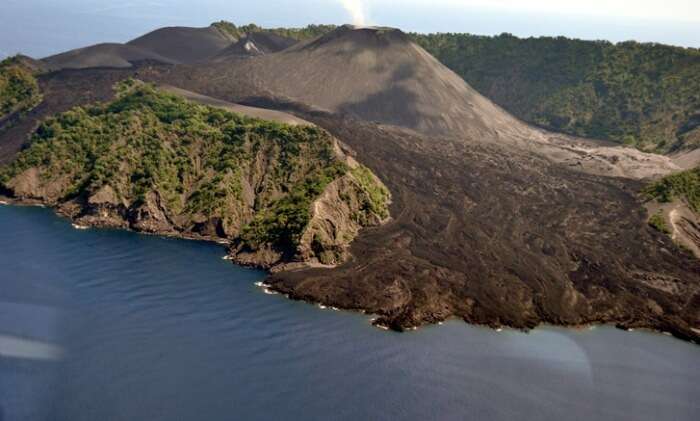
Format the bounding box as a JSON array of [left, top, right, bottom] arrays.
[[204, 26, 494, 134]]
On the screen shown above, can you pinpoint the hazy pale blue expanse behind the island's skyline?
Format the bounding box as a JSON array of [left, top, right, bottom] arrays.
[[0, 0, 700, 57]]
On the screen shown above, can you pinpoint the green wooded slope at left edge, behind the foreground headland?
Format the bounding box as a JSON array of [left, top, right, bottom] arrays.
[[0, 56, 41, 121]]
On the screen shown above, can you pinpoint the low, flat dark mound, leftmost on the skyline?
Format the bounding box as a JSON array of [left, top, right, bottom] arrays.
[[42, 43, 174, 70]]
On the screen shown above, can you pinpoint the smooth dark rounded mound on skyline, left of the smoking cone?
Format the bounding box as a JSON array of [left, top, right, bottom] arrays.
[[127, 26, 237, 63]]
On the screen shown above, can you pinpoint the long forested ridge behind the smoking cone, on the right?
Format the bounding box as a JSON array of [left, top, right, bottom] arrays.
[[412, 34, 700, 153]]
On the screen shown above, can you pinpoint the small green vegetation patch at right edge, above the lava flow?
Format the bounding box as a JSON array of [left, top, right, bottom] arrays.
[[644, 167, 700, 209]]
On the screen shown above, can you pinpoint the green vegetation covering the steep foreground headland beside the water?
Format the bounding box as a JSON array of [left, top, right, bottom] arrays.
[[0, 80, 388, 254]]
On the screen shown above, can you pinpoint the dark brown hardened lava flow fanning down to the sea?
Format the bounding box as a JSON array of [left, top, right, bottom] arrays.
[[268, 116, 700, 341]]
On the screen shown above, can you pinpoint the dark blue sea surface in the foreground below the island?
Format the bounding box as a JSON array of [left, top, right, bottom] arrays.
[[0, 206, 700, 421]]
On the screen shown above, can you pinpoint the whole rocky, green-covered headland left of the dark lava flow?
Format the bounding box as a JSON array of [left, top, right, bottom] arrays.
[[0, 81, 389, 267]]
